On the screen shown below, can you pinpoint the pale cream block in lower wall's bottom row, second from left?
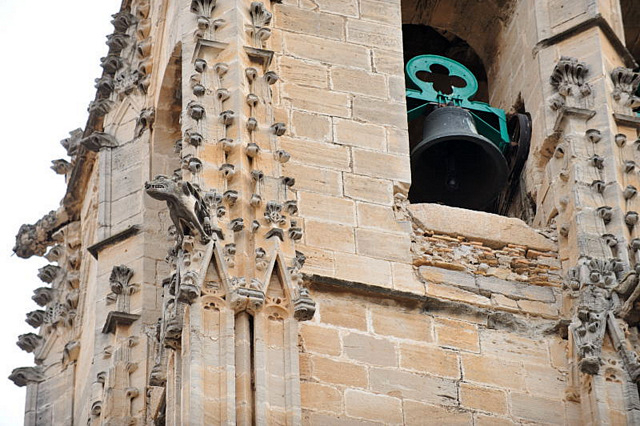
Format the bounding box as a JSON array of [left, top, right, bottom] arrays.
[[344, 389, 403, 424]]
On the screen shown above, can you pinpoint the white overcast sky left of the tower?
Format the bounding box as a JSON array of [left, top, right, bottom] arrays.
[[0, 0, 120, 425]]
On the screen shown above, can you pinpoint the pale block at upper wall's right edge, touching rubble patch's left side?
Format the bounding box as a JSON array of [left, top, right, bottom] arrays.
[[356, 228, 411, 261]]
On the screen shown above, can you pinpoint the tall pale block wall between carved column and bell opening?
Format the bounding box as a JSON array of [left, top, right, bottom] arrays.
[[272, 0, 411, 287]]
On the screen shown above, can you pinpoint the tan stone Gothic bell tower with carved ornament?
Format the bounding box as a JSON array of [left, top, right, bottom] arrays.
[[10, 0, 640, 425]]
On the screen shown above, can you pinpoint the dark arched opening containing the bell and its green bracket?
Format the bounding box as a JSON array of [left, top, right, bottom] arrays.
[[403, 24, 530, 216]]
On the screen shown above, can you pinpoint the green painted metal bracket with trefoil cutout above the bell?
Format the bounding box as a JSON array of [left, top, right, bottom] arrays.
[[405, 55, 510, 152]]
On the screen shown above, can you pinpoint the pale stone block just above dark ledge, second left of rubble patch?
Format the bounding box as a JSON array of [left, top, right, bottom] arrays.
[[336, 253, 391, 287]]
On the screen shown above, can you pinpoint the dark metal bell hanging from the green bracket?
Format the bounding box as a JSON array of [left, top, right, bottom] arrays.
[[409, 106, 508, 210]]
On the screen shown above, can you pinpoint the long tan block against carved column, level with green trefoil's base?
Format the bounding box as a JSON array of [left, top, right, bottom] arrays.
[[282, 83, 351, 117]]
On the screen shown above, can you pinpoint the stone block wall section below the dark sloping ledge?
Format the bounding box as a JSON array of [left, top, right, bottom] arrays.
[[299, 286, 580, 425]]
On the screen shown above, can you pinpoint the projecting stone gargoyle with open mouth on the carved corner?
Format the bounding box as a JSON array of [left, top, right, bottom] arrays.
[[144, 175, 224, 246]]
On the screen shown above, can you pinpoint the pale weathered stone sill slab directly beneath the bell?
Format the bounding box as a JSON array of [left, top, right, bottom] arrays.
[[409, 203, 557, 251]]
